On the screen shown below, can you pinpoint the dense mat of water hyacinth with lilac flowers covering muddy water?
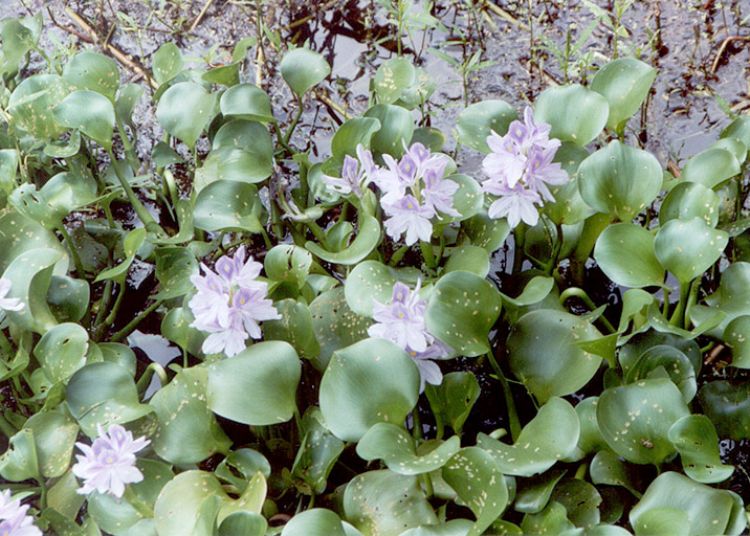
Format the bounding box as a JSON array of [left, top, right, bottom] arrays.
[[0, 1, 750, 536]]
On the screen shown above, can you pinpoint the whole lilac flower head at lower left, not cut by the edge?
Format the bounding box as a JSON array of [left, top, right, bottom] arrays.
[[73, 424, 149, 498]]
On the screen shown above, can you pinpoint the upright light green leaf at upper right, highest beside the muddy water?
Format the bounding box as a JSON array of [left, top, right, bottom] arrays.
[[591, 58, 656, 131]]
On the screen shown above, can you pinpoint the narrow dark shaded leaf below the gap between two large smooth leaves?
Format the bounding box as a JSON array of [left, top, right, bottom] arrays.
[[292, 406, 344, 495]]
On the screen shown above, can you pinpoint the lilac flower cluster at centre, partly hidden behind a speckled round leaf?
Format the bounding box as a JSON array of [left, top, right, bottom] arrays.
[[367, 282, 451, 393]]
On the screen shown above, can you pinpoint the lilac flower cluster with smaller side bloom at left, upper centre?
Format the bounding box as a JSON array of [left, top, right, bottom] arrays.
[[324, 143, 460, 246]]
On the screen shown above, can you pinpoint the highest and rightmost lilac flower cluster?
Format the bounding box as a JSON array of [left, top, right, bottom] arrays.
[[482, 107, 568, 228]]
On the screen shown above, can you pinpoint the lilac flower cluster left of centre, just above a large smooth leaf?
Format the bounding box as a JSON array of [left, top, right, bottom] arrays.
[[189, 246, 281, 357]]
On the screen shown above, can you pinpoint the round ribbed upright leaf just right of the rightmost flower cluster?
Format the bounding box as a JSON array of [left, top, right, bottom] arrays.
[[578, 141, 662, 222]]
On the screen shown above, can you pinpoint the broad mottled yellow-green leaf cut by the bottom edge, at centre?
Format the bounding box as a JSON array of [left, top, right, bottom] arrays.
[[344, 471, 438, 536]]
